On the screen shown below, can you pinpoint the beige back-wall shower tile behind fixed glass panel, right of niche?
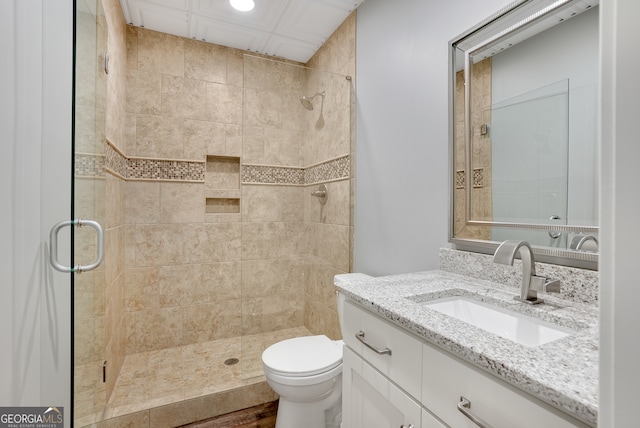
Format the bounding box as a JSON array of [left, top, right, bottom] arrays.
[[241, 56, 306, 340]]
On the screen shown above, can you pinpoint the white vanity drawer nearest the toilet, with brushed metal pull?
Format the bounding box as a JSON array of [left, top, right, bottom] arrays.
[[343, 301, 422, 398]]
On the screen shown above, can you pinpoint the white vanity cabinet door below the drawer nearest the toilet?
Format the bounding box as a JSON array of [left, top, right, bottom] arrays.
[[342, 346, 422, 428]]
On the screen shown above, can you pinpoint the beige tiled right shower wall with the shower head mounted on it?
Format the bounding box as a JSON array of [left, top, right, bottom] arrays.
[[303, 12, 356, 339]]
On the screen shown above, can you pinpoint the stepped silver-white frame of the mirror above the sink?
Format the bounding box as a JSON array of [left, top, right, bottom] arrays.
[[448, 0, 600, 270]]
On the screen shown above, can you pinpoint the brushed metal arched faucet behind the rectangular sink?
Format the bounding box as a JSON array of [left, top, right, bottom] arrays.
[[493, 240, 560, 305]]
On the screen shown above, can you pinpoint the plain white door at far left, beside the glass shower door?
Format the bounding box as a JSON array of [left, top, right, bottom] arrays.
[[0, 0, 73, 426]]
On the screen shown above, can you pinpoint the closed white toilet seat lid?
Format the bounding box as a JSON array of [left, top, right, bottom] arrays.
[[262, 335, 342, 377]]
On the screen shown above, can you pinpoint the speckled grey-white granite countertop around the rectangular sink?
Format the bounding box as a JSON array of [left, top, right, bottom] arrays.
[[336, 271, 598, 426]]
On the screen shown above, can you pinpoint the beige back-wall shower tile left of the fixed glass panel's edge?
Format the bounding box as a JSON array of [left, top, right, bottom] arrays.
[[125, 27, 242, 354]]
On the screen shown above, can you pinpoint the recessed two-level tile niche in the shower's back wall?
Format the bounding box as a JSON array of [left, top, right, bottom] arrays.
[[205, 156, 240, 214]]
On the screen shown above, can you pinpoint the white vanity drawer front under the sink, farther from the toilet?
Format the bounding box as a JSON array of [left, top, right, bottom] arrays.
[[422, 345, 588, 428]]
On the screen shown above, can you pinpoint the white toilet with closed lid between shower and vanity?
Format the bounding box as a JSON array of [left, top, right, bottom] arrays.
[[262, 273, 371, 428]]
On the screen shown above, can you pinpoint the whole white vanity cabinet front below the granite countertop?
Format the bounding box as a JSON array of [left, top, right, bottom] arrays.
[[342, 301, 588, 428]]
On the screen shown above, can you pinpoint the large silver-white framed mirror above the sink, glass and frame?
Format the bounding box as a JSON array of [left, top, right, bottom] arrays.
[[449, 0, 599, 269]]
